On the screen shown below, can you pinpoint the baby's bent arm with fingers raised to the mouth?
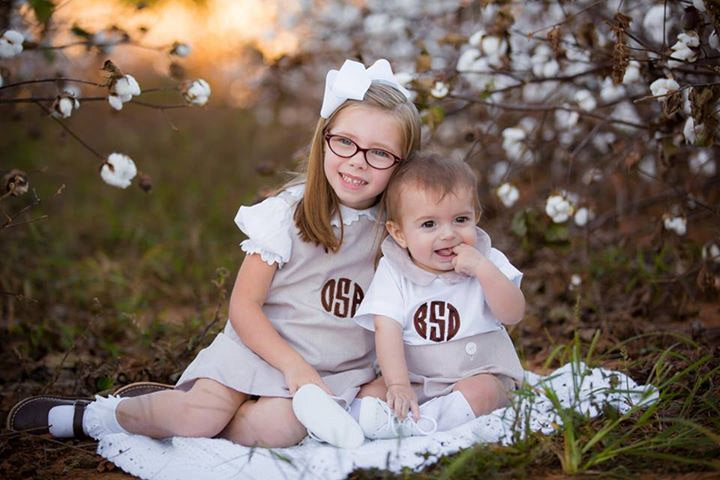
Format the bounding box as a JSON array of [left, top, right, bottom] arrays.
[[453, 243, 525, 325]]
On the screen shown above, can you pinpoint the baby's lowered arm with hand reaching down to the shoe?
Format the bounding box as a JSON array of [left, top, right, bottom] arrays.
[[375, 315, 420, 420]]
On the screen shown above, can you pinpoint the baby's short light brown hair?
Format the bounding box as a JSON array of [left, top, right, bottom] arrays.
[[384, 152, 482, 221]]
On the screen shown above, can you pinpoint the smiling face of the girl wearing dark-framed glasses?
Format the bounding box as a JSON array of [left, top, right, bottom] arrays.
[[323, 105, 403, 210]]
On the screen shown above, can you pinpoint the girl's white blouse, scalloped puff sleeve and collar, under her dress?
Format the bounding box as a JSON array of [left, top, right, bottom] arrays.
[[235, 184, 377, 268]]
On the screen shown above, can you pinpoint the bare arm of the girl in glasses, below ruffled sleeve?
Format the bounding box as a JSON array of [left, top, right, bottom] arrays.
[[230, 254, 331, 393]]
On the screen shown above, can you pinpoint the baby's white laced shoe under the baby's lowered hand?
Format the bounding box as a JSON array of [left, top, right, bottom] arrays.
[[360, 397, 437, 440]]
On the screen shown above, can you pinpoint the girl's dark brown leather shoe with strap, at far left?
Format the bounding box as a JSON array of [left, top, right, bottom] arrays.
[[6, 395, 92, 438]]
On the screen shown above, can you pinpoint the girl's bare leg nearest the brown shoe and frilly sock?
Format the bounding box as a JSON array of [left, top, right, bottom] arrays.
[[115, 378, 247, 438]]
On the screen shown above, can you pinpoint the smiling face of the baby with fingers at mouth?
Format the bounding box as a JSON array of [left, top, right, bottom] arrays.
[[387, 185, 477, 273]]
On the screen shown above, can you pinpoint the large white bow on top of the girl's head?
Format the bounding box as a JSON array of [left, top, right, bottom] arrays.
[[320, 58, 410, 118]]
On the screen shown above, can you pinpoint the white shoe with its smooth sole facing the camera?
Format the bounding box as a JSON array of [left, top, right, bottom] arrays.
[[292, 383, 365, 448]]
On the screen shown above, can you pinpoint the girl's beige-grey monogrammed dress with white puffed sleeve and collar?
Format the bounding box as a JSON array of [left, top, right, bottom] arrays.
[[176, 185, 378, 403]]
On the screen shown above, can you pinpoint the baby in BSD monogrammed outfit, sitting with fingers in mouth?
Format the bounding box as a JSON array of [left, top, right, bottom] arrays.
[[355, 154, 525, 438]]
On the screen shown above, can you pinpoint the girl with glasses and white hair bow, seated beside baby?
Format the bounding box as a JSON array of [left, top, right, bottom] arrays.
[[8, 60, 420, 447]]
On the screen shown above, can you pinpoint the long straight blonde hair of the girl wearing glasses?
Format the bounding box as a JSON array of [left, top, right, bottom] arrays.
[[291, 82, 420, 252]]
